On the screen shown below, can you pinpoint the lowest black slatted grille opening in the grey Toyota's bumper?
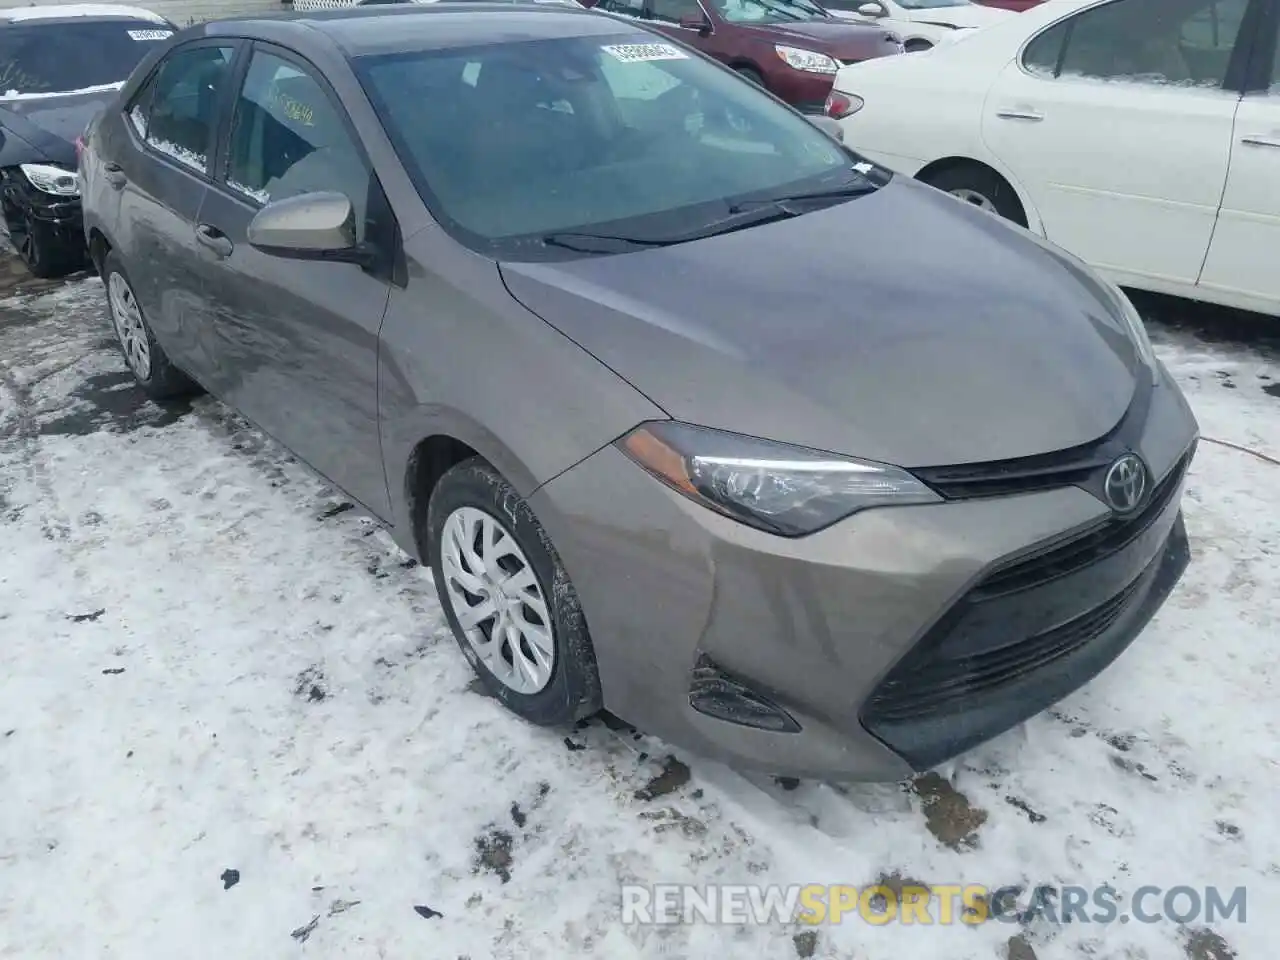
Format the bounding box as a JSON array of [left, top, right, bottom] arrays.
[[867, 576, 1146, 723]]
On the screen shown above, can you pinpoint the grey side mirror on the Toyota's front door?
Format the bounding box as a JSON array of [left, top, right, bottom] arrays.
[[248, 192, 369, 264]]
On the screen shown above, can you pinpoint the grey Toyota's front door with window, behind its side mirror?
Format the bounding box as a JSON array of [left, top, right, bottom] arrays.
[[195, 46, 390, 517]]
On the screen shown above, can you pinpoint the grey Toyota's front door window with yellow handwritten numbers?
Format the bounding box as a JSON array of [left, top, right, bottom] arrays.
[[227, 51, 369, 230]]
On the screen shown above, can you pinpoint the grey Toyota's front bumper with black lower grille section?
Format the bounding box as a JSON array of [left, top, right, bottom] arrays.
[[530, 371, 1196, 780]]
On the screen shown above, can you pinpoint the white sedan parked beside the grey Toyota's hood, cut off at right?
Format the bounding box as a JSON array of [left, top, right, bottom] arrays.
[[828, 0, 1280, 320]]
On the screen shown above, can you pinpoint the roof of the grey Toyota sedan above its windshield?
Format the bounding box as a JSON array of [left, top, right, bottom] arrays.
[[206, 0, 636, 56]]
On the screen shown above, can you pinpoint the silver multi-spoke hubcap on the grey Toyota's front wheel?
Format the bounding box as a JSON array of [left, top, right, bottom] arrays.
[[440, 507, 556, 694]]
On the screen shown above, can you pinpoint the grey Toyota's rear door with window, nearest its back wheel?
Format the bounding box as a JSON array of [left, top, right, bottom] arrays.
[[115, 41, 237, 371]]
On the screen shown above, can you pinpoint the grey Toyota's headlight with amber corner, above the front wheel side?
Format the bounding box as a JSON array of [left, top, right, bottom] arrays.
[[618, 421, 940, 536]]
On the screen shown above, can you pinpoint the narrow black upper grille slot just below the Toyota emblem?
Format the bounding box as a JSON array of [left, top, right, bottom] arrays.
[[973, 447, 1196, 600]]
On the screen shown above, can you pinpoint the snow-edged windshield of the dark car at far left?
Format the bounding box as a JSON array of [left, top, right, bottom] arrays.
[[0, 19, 173, 100]]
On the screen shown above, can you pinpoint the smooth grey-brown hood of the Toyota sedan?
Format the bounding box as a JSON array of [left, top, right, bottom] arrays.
[[502, 178, 1142, 467]]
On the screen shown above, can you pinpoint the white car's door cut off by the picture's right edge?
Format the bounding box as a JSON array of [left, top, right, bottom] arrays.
[[1199, 5, 1280, 312]]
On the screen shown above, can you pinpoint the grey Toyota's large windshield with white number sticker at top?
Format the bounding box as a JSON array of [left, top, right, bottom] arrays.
[[356, 33, 873, 260]]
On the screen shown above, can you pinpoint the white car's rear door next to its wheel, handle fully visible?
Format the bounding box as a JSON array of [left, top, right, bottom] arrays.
[[982, 0, 1251, 285]]
